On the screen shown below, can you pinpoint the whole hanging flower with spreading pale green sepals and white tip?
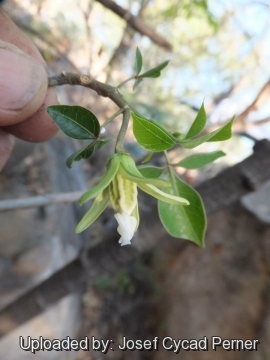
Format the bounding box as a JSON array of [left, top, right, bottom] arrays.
[[75, 153, 189, 245]]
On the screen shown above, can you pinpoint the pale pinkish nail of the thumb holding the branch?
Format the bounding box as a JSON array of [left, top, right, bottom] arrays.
[[0, 48, 44, 111]]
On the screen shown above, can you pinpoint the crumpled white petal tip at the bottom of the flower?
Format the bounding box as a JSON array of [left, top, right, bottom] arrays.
[[114, 212, 137, 246]]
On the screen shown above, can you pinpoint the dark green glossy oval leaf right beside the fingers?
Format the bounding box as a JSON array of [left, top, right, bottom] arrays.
[[47, 105, 100, 140]]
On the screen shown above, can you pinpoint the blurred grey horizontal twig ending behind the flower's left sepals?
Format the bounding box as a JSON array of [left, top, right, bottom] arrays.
[[0, 191, 83, 212]]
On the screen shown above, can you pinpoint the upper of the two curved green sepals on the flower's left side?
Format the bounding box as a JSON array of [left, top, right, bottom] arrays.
[[79, 155, 120, 205]]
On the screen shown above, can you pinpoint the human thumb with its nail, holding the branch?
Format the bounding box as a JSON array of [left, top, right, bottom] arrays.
[[0, 40, 48, 126]]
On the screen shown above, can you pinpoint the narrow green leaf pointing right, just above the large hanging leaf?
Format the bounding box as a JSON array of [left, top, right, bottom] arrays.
[[173, 151, 226, 169]]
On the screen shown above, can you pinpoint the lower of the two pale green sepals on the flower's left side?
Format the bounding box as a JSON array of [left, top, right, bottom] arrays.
[[75, 188, 110, 234]]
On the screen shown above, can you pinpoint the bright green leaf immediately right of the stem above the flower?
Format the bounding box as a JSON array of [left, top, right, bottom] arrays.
[[131, 113, 176, 152]]
